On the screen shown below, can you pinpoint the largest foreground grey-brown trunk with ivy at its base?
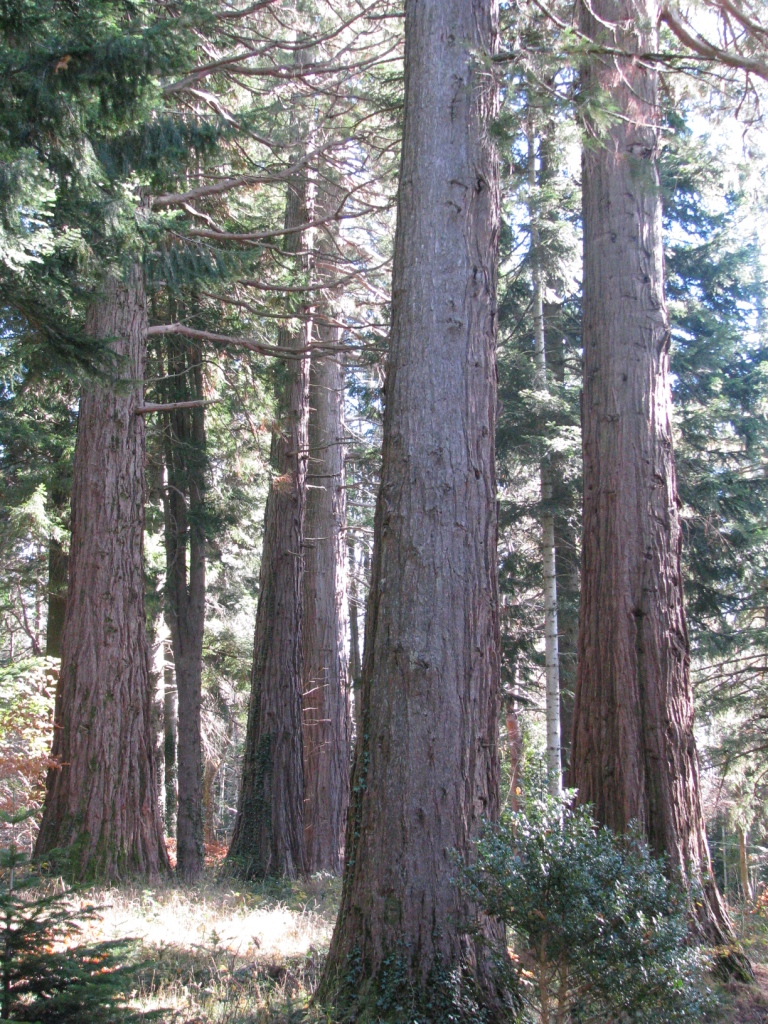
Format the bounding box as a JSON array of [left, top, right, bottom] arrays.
[[318, 0, 512, 1022]]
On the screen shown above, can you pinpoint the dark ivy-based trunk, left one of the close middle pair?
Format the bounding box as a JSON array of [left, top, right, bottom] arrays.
[[227, 177, 312, 878]]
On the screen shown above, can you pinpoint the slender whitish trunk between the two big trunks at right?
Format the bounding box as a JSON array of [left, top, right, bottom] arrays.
[[528, 126, 562, 797]]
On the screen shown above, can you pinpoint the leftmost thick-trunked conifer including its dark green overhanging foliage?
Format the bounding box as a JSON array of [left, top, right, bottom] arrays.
[[3, 3, 219, 879]]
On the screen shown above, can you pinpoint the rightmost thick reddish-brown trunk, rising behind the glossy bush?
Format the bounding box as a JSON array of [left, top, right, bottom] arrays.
[[571, 0, 749, 973]]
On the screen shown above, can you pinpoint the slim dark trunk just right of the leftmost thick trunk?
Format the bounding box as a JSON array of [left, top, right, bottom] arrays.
[[163, 340, 206, 882]]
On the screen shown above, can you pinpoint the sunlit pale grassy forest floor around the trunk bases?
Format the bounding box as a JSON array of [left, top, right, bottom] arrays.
[[69, 874, 768, 1024]]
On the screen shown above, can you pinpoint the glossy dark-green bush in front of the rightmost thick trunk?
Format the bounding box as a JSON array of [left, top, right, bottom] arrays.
[[464, 799, 711, 1024]]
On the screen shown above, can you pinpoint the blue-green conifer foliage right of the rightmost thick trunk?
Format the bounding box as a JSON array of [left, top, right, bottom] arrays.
[[662, 115, 768, 659]]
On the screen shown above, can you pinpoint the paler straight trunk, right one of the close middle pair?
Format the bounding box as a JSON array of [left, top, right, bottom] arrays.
[[302, 317, 350, 872]]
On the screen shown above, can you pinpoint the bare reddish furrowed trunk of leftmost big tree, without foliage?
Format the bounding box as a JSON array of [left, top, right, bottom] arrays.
[[35, 267, 169, 881]]
